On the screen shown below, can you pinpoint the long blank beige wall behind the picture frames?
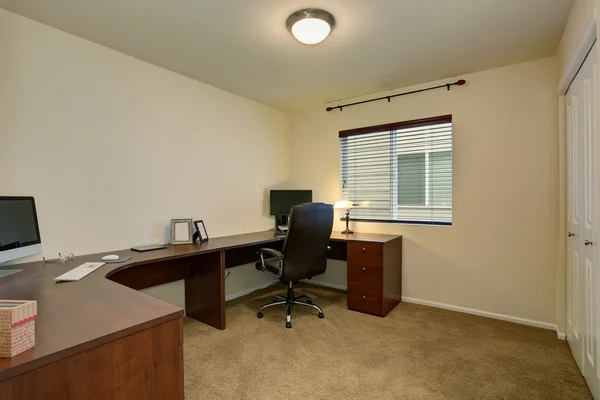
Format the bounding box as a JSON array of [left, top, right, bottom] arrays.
[[0, 10, 290, 296]]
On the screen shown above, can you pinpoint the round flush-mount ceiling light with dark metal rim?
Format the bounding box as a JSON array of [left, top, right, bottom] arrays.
[[286, 8, 335, 44]]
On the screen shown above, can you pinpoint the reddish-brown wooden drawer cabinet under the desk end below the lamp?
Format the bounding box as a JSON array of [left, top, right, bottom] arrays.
[[347, 237, 402, 317]]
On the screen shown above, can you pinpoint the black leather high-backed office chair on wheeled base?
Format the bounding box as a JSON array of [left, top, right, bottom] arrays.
[[256, 203, 333, 328]]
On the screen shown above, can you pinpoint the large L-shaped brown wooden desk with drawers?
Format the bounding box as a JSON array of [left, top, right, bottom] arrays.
[[0, 231, 402, 400]]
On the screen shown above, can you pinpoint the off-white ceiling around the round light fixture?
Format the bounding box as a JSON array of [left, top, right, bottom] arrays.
[[0, 0, 573, 110]]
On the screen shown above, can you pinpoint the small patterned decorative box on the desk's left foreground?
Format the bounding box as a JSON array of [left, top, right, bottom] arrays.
[[0, 300, 37, 357]]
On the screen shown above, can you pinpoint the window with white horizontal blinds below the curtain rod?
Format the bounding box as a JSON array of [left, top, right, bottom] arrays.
[[340, 115, 452, 225]]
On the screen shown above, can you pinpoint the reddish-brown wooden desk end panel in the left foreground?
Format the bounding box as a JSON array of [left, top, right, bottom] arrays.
[[0, 318, 183, 400]]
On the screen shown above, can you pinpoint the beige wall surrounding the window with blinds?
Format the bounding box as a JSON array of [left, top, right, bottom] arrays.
[[292, 58, 558, 325]]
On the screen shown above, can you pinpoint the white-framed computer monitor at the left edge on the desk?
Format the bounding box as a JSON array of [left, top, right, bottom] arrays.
[[0, 196, 42, 263]]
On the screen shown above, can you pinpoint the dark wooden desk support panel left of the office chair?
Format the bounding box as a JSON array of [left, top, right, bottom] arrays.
[[185, 251, 225, 329]]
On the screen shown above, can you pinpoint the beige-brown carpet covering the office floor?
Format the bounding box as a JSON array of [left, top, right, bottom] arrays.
[[184, 285, 591, 400]]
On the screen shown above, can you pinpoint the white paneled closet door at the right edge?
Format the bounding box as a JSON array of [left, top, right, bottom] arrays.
[[566, 42, 600, 399]]
